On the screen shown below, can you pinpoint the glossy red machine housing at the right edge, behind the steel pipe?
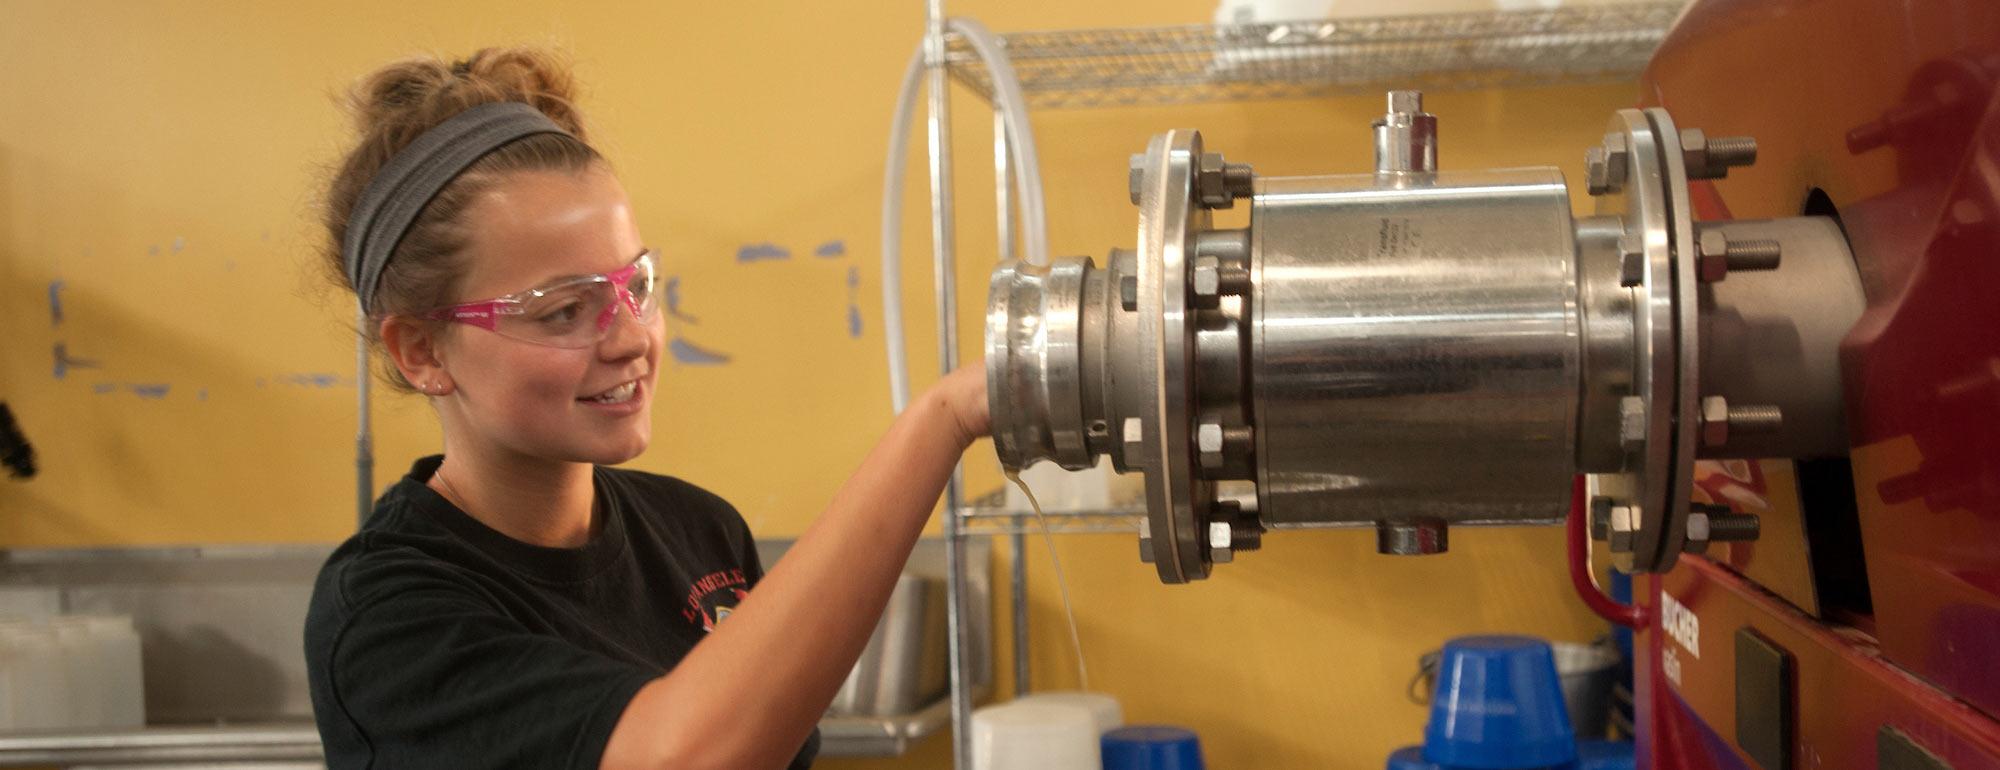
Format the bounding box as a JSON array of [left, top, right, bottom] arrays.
[[1634, 0, 2000, 770]]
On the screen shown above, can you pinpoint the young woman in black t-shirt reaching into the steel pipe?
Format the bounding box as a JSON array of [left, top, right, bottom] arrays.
[[306, 50, 988, 768]]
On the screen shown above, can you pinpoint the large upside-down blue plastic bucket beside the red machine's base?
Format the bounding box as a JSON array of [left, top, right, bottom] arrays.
[[1424, 636, 1576, 770]]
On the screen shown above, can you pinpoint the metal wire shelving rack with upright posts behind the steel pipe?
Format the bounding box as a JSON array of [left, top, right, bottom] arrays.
[[908, 0, 1686, 768]]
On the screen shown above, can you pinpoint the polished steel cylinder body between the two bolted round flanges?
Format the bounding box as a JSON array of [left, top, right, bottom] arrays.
[[1250, 168, 1580, 528]]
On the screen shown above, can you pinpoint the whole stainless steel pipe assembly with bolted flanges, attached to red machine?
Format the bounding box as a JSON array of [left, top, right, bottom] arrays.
[[986, 92, 1862, 582]]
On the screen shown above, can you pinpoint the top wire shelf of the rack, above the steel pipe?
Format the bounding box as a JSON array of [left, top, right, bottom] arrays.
[[948, 0, 1686, 110]]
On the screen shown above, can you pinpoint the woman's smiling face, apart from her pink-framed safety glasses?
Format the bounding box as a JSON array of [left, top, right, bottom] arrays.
[[436, 166, 664, 464]]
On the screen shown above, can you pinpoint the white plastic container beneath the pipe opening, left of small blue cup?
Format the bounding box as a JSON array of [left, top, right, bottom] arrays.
[[972, 700, 1104, 770]]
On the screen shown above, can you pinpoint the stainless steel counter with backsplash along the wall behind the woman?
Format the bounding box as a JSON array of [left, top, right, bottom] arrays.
[[0, 540, 992, 770]]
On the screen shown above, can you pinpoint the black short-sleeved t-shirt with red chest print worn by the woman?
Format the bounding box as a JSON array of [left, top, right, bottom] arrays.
[[306, 456, 820, 770]]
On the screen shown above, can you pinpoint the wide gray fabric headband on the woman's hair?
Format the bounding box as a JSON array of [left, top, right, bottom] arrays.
[[340, 102, 570, 314]]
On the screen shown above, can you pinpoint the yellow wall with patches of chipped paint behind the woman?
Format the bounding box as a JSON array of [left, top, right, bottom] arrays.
[[0, 0, 1632, 768]]
